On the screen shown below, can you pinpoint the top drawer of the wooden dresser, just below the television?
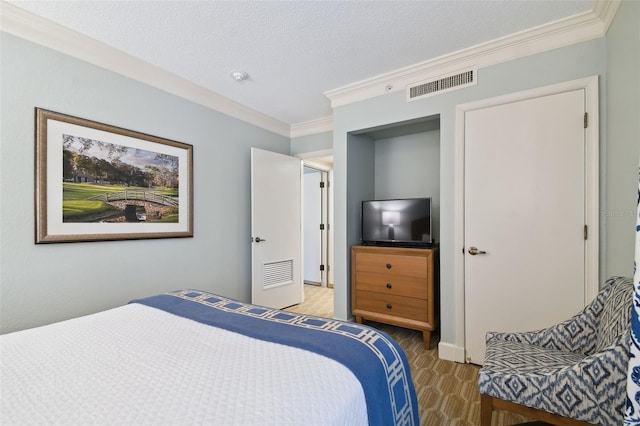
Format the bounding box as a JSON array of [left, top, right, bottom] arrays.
[[356, 253, 427, 279]]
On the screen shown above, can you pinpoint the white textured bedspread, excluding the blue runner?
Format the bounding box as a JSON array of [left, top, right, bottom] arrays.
[[0, 304, 367, 426]]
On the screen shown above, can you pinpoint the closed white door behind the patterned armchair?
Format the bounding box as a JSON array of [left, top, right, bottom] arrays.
[[464, 89, 585, 364]]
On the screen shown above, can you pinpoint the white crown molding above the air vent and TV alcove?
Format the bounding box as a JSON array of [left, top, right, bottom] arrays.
[[324, 0, 620, 108]]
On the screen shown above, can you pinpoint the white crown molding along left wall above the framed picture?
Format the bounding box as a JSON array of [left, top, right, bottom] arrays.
[[0, 0, 291, 137]]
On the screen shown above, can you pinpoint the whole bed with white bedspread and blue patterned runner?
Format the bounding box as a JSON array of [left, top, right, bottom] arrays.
[[0, 290, 419, 425]]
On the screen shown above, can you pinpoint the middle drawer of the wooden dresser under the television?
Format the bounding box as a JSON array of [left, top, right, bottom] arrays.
[[355, 271, 429, 299]]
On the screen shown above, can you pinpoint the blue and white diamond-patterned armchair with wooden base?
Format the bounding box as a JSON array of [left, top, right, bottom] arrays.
[[478, 277, 633, 426]]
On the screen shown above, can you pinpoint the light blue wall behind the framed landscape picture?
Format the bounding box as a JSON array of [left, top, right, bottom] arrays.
[[0, 33, 290, 333]]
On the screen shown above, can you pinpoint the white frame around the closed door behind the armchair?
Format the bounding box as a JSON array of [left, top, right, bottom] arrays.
[[439, 76, 600, 362]]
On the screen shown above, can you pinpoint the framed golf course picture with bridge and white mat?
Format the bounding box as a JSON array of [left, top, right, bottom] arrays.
[[35, 108, 193, 244]]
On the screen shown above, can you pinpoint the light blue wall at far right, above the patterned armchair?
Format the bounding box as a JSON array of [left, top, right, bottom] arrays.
[[601, 1, 640, 276]]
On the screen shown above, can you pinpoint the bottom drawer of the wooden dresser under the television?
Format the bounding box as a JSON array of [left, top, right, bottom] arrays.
[[356, 290, 429, 322]]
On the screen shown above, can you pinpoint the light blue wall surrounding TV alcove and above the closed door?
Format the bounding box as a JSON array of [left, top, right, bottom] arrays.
[[334, 38, 608, 345]]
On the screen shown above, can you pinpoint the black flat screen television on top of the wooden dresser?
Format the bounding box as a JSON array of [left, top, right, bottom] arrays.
[[361, 197, 433, 247]]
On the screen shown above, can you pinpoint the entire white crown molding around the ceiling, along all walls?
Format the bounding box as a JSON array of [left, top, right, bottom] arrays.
[[0, 0, 621, 138]]
